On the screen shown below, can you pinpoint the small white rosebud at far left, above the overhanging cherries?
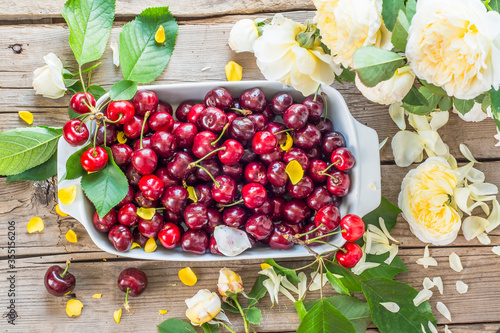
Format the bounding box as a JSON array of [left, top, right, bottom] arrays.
[[33, 53, 66, 99]]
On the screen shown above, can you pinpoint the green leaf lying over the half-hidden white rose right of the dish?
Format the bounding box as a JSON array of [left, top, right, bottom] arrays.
[[354, 46, 405, 87]]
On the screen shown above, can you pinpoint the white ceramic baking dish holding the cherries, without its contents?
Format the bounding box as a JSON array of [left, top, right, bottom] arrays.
[[57, 81, 381, 261]]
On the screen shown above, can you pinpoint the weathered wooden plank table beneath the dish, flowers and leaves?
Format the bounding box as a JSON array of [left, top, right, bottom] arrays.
[[0, 0, 500, 333]]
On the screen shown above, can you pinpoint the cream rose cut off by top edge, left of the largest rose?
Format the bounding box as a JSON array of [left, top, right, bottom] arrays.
[[314, 0, 392, 68]]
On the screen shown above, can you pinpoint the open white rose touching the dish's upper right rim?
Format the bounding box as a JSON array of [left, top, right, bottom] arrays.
[[253, 14, 341, 96]]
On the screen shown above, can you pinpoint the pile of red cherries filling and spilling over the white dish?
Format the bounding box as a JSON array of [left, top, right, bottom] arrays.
[[63, 87, 364, 267]]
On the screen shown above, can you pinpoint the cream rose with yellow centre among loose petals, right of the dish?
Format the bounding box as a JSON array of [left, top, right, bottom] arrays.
[[398, 157, 461, 245]]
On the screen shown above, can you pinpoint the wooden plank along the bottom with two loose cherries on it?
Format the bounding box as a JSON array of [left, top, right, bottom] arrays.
[[0, 248, 500, 332]]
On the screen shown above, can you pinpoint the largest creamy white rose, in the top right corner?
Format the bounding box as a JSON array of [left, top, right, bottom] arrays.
[[406, 0, 500, 99]]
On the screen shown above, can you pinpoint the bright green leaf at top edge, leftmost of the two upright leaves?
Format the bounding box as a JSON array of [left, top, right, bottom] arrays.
[[62, 0, 115, 66]]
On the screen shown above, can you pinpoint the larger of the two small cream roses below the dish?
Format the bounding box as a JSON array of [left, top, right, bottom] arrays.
[[186, 289, 221, 325]]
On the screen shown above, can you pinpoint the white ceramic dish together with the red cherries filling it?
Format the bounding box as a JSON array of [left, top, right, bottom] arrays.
[[57, 81, 380, 265]]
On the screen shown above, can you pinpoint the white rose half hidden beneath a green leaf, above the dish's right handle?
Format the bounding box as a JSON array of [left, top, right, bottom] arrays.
[[356, 66, 415, 105]]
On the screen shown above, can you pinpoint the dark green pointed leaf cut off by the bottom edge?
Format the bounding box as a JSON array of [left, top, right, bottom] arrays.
[[297, 299, 356, 333]]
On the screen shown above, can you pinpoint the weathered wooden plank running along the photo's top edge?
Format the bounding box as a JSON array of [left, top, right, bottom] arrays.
[[0, 0, 314, 21]]
